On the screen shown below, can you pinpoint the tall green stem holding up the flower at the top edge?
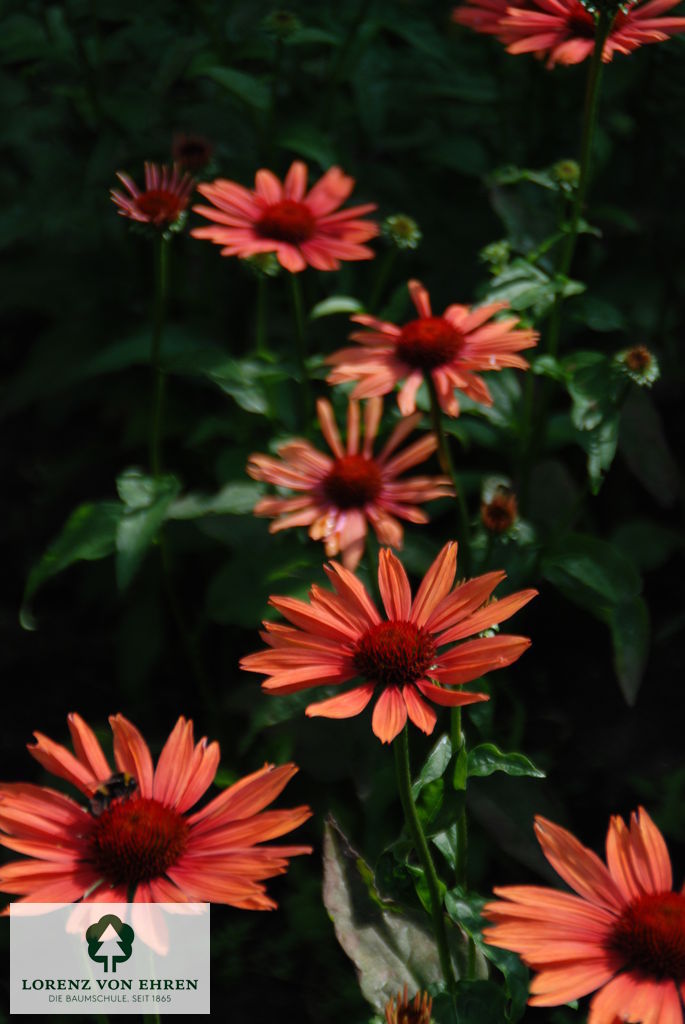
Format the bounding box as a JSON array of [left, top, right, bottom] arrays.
[[546, 10, 613, 355]]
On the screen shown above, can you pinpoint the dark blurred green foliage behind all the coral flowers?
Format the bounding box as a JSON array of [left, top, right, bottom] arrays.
[[0, 0, 685, 1024]]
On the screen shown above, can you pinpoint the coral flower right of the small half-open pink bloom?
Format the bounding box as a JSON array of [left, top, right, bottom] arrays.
[[190, 160, 378, 273]]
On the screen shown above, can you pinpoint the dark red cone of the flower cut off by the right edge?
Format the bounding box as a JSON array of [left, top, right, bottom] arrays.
[[609, 893, 685, 982]]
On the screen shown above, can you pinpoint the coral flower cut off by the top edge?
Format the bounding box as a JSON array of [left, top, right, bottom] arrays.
[[453, 0, 685, 68]]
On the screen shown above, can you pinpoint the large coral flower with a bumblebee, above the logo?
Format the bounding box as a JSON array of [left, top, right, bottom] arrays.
[[0, 714, 311, 910]]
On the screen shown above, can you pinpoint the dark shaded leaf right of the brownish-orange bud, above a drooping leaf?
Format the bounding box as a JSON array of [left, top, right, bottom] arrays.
[[542, 534, 642, 617]]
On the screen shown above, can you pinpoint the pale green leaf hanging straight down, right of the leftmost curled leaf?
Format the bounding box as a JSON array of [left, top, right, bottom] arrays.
[[116, 469, 180, 590]]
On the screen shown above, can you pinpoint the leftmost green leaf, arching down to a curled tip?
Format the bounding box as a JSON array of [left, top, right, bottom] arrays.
[[19, 502, 123, 629]]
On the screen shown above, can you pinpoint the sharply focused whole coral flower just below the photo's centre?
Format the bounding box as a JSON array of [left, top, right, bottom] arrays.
[[241, 542, 537, 743]]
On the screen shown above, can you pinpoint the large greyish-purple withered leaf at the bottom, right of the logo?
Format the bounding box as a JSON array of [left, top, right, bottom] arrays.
[[324, 818, 475, 1013]]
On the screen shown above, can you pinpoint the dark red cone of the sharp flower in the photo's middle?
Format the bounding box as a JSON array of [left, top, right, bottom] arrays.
[[353, 620, 436, 686]]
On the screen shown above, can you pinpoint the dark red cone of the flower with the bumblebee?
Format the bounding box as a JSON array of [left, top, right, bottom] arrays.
[[90, 798, 189, 887]]
